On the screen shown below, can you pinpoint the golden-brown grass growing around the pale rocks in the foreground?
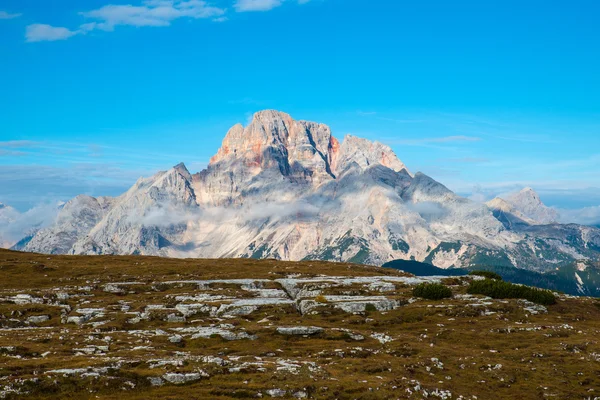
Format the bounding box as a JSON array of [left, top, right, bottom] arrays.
[[0, 250, 600, 400]]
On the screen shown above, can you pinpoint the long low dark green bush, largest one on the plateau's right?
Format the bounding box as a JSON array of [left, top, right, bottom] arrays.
[[467, 279, 556, 305]]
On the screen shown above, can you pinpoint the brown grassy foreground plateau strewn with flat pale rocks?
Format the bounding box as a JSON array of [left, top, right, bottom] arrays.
[[0, 250, 600, 399]]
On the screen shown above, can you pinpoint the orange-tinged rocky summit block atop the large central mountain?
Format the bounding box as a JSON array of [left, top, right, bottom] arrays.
[[210, 110, 408, 182]]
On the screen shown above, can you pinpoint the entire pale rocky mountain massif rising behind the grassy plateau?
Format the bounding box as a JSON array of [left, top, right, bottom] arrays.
[[25, 110, 600, 278]]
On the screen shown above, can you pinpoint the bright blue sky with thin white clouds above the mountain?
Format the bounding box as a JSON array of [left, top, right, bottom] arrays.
[[0, 0, 600, 223]]
